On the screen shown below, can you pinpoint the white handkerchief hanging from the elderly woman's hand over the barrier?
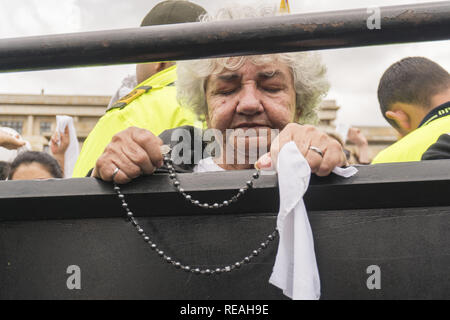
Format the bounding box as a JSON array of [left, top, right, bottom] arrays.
[[269, 142, 357, 300]]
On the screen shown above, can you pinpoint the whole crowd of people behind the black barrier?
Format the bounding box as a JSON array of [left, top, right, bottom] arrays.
[[0, 0, 450, 183]]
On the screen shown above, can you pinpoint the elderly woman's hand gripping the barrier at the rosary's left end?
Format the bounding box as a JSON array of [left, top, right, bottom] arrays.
[[92, 127, 163, 184]]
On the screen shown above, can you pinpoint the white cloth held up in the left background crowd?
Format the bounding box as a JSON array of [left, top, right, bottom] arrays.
[[56, 116, 80, 178]]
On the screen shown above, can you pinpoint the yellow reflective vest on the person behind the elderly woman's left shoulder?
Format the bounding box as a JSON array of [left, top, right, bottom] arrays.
[[73, 66, 198, 177]]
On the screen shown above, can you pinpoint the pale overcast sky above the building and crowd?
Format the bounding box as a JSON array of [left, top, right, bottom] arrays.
[[0, 0, 450, 125]]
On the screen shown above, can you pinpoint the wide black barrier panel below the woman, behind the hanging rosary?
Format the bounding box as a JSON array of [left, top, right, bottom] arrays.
[[0, 160, 450, 300]]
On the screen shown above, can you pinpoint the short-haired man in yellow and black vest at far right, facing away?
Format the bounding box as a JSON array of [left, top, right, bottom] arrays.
[[372, 57, 450, 163]]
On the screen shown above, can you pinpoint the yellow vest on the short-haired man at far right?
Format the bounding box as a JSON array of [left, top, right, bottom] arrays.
[[372, 104, 450, 164]]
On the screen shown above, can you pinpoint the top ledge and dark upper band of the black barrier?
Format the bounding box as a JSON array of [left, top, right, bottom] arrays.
[[0, 160, 450, 222]]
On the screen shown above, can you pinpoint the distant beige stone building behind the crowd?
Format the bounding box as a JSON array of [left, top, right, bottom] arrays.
[[0, 94, 397, 155]]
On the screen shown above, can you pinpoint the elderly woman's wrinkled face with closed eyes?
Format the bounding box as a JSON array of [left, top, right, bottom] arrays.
[[206, 61, 296, 160]]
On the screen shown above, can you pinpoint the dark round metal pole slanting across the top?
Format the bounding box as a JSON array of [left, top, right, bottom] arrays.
[[0, 1, 450, 72]]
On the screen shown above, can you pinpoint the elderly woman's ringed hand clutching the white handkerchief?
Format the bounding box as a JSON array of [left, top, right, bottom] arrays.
[[256, 123, 347, 176]]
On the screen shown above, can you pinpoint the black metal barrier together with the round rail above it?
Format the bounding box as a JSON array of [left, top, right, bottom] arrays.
[[0, 1, 450, 299]]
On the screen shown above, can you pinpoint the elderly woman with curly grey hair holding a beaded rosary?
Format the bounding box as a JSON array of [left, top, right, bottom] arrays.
[[93, 7, 346, 183]]
